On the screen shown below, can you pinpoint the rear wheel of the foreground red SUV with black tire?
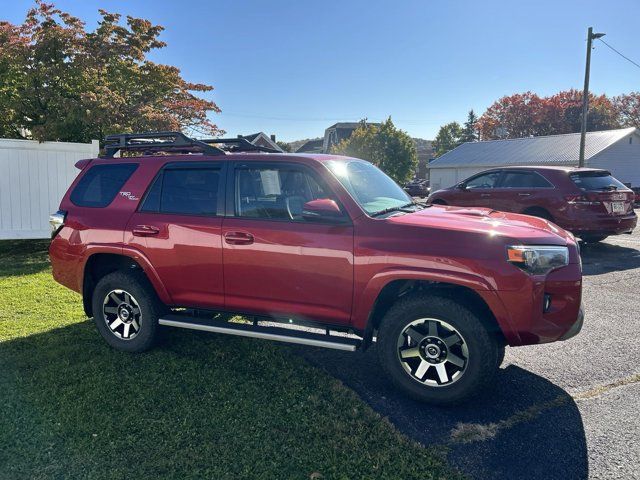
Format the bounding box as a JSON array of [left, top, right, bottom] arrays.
[[92, 271, 165, 352]]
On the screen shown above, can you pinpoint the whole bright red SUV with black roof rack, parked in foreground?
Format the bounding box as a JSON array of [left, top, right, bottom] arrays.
[[50, 133, 583, 404]]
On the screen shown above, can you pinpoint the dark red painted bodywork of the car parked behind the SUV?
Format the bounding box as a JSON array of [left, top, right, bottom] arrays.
[[428, 167, 638, 236]]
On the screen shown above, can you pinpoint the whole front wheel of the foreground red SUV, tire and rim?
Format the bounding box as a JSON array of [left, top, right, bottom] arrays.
[[378, 294, 500, 405]]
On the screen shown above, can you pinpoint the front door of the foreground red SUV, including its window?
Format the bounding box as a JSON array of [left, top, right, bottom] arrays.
[[222, 162, 353, 325]]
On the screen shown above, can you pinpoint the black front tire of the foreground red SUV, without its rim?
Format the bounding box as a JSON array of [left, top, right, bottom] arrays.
[[377, 294, 500, 405]]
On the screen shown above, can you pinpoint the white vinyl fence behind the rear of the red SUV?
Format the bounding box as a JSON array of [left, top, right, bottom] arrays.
[[0, 138, 99, 239]]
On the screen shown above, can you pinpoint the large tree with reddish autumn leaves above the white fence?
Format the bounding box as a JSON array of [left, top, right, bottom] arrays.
[[0, 0, 220, 142]]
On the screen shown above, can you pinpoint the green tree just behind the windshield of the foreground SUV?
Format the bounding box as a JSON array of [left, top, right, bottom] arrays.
[[332, 117, 418, 183]]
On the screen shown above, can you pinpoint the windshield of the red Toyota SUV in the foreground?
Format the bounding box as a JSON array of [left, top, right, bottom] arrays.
[[328, 160, 412, 215]]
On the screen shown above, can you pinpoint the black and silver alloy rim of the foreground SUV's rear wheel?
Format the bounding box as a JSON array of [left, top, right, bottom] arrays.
[[102, 290, 142, 340]]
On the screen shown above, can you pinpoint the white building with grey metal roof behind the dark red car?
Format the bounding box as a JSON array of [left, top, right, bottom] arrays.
[[429, 128, 640, 191]]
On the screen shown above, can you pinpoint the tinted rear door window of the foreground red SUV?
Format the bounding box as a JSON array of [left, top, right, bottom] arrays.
[[141, 168, 220, 215]]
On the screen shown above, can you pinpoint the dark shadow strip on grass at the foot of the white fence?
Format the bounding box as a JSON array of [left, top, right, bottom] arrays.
[[0, 240, 50, 278]]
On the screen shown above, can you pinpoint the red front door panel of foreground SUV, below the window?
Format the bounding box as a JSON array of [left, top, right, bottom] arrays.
[[222, 218, 353, 324]]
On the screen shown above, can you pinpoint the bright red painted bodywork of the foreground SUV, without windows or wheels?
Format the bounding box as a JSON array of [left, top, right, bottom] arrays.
[[50, 154, 582, 345]]
